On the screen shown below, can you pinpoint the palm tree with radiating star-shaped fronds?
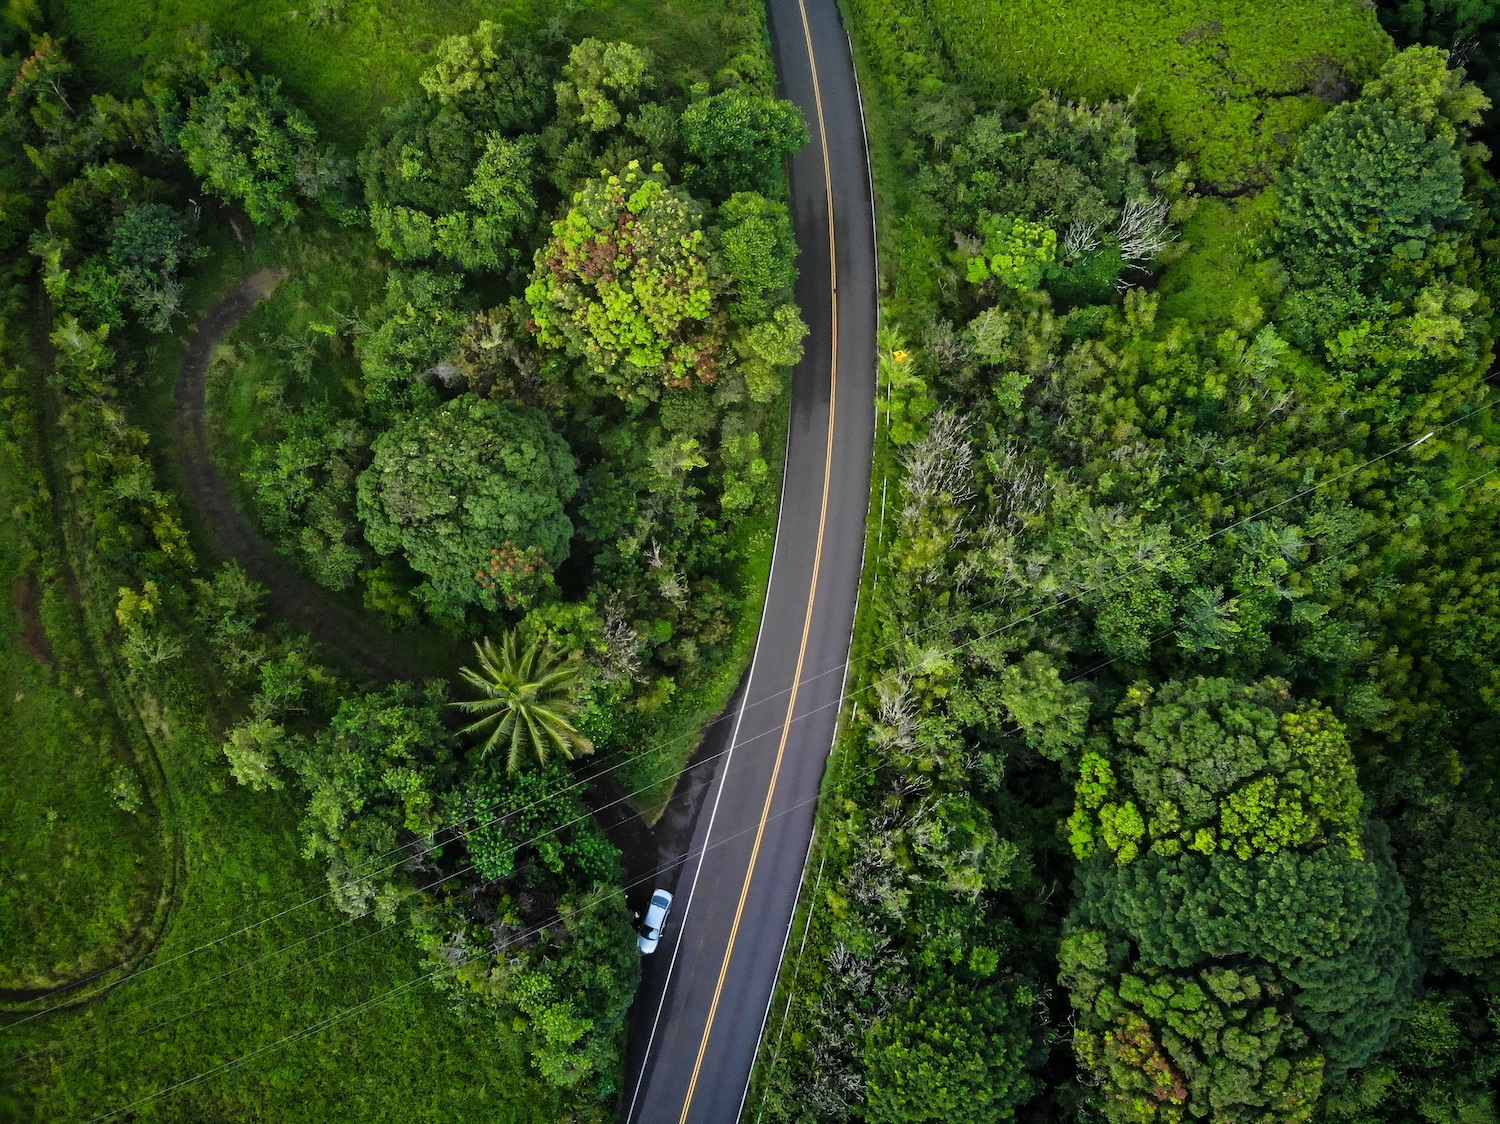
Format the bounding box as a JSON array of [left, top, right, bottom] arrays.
[[452, 629, 594, 773]]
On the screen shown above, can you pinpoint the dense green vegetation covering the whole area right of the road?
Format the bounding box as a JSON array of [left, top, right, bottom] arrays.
[[750, 0, 1500, 1124]]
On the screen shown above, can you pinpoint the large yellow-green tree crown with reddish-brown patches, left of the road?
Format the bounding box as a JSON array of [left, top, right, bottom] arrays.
[[527, 162, 723, 398]]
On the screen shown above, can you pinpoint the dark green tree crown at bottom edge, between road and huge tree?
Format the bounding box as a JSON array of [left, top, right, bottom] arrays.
[[866, 987, 1034, 1124]]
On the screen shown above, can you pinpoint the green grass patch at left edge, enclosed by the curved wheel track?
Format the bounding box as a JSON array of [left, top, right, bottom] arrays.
[[0, 450, 170, 989]]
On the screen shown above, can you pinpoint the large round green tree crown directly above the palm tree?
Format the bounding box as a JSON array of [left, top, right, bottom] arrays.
[[359, 396, 578, 617]]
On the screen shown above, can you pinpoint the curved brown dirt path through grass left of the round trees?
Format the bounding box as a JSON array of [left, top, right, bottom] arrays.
[[176, 269, 420, 680]]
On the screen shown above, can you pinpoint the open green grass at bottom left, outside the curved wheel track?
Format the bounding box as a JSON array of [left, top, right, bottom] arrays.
[[0, 723, 566, 1124]]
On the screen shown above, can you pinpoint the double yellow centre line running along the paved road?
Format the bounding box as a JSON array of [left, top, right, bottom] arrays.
[[678, 0, 839, 1124]]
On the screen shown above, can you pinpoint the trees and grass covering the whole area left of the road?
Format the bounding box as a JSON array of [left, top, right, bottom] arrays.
[[0, 0, 806, 1121]]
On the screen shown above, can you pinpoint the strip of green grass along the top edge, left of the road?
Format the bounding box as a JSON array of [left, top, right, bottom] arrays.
[[51, 0, 774, 149]]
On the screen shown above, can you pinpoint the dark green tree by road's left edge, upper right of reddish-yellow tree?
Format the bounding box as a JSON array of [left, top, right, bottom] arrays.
[[683, 90, 809, 198]]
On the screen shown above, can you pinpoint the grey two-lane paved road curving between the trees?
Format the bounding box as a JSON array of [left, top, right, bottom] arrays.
[[623, 0, 876, 1124]]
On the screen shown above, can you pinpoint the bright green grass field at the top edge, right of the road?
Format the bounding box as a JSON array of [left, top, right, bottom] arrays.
[[927, 0, 1392, 189]]
